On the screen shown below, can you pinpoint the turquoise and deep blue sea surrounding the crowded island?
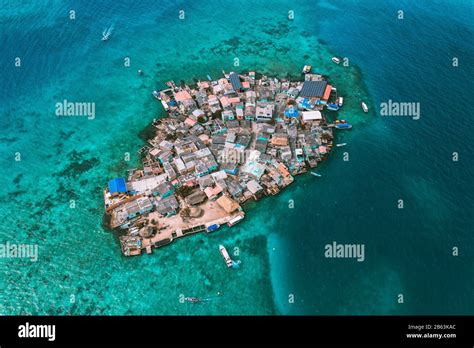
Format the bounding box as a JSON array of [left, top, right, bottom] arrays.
[[0, 0, 474, 315]]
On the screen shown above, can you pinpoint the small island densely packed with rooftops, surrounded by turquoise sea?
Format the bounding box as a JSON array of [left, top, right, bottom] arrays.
[[104, 66, 351, 256]]
